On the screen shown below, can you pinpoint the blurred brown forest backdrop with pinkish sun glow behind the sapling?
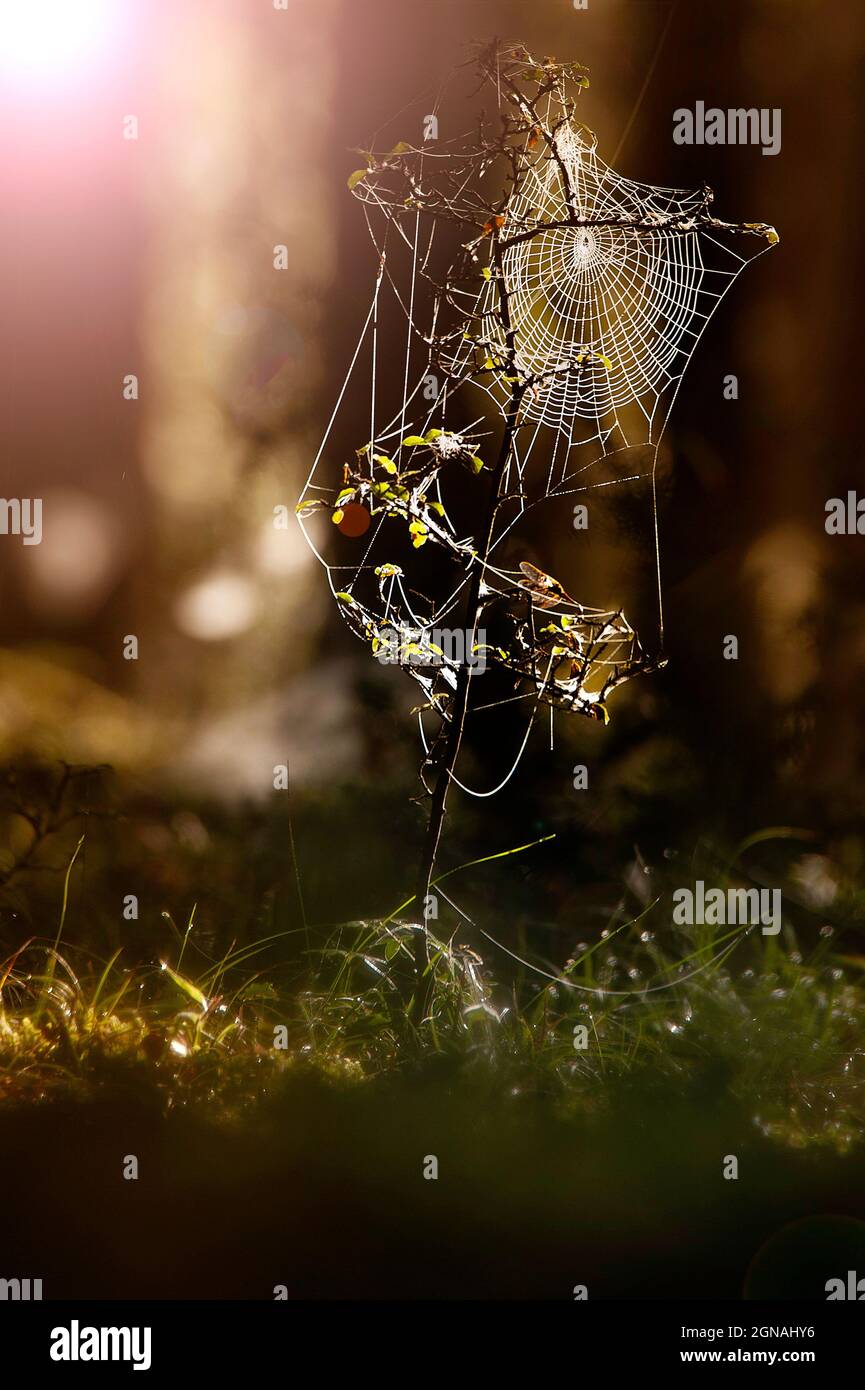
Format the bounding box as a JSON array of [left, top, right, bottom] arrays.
[[0, 0, 865, 956]]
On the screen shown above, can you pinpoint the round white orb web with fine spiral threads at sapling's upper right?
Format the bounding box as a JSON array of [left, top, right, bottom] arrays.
[[453, 125, 712, 439]]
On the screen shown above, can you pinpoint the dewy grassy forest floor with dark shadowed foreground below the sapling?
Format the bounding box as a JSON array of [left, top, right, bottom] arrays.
[[0, 761, 865, 1298]]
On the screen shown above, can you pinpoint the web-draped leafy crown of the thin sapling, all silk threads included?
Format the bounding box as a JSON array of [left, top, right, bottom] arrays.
[[298, 48, 777, 796]]
